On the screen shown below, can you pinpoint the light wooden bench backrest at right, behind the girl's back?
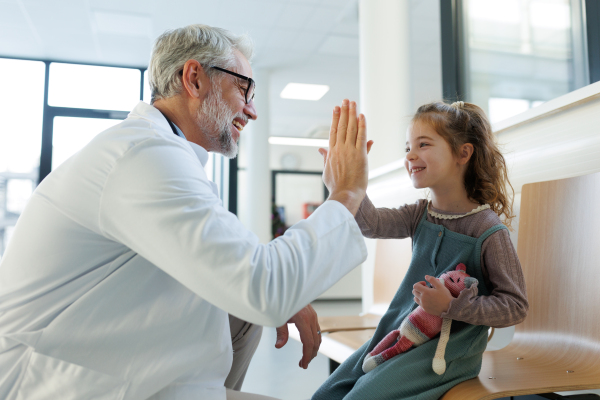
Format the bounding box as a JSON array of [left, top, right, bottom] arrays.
[[513, 173, 600, 362]]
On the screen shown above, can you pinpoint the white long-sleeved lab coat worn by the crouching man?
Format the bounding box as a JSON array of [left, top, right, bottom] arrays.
[[0, 102, 366, 400]]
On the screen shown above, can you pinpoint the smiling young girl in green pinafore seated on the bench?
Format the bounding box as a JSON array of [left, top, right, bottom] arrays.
[[313, 101, 528, 400]]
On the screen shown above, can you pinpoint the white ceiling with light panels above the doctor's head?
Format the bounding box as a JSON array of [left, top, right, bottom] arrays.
[[0, 0, 359, 136]]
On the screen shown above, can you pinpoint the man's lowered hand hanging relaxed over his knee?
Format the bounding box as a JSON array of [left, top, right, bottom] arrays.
[[275, 304, 321, 369]]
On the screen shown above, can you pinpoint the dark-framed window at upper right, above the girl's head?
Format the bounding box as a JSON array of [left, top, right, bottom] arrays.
[[442, 0, 589, 122]]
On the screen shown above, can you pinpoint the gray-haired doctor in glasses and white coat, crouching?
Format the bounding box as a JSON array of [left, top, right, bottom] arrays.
[[0, 25, 371, 400]]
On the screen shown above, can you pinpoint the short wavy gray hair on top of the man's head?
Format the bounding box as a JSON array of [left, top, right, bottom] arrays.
[[148, 25, 254, 103]]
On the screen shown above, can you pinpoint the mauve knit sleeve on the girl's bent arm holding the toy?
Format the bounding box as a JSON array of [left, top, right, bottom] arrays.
[[442, 229, 529, 328]]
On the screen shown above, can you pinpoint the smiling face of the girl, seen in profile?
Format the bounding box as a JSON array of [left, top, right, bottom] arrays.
[[404, 121, 463, 189]]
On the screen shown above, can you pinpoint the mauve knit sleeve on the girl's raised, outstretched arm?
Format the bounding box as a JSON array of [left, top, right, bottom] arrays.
[[355, 196, 427, 239]]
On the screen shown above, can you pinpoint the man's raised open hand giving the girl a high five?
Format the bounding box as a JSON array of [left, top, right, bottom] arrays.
[[319, 100, 372, 215]]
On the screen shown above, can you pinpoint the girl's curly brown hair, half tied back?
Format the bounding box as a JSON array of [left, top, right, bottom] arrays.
[[412, 101, 515, 230]]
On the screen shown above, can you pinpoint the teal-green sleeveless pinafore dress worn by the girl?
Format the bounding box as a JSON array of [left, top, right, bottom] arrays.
[[312, 209, 507, 400]]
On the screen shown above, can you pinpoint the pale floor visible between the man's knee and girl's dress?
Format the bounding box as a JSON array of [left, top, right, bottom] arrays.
[[242, 300, 361, 400]]
